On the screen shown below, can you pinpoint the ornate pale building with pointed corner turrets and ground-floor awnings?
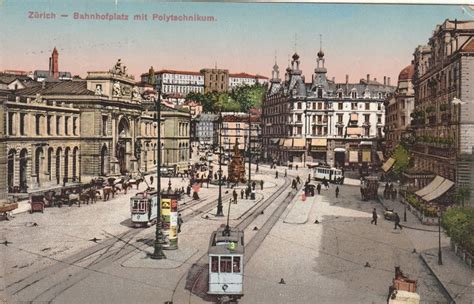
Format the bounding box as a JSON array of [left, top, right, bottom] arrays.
[[262, 50, 395, 166]]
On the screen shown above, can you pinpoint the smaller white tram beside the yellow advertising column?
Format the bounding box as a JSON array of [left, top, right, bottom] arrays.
[[130, 191, 158, 227]]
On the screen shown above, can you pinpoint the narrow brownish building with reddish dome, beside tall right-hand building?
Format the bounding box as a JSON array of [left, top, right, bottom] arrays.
[[385, 64, 415, 155]]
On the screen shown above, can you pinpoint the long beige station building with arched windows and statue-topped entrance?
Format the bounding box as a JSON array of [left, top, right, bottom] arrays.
[[0, 59, 189, 197]]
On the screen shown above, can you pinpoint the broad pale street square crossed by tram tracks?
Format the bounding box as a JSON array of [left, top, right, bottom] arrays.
[[0, 165, 446, 303]]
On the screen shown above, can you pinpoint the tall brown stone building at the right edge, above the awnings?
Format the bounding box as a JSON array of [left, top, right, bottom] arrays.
[[412, 20, 474, 201]]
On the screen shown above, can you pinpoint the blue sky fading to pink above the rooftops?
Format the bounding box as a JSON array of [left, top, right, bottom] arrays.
[[0, 0, 474, 84]]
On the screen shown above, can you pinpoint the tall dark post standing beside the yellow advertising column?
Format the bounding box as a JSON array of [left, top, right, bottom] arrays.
[[150, 84, 166, 260]]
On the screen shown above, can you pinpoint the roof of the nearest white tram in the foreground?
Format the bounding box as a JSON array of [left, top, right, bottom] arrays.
[[209, 227, 244, 254]]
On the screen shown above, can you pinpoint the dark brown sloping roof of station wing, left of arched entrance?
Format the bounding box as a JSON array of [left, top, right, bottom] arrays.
[[18, 80, 94, 95]]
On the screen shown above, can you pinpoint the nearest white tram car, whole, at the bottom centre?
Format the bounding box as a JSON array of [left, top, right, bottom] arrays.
[[207, 227, 244, 303]]
